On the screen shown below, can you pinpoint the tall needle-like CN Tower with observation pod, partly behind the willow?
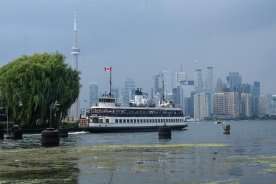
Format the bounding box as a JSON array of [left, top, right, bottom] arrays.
[[69, 14, 80, 120]]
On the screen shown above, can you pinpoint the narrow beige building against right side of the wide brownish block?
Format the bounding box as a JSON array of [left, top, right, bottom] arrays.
[[241, 93, 253, 118]]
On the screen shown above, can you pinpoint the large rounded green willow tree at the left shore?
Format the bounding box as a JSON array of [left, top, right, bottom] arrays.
[[0, 53, 80, 127]]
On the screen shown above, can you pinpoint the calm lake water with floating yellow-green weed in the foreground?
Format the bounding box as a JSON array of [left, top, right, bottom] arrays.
[[0, 121, 276, 184]]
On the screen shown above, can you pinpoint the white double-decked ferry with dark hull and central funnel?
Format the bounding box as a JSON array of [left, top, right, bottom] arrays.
[[87, 89, 187, 133]]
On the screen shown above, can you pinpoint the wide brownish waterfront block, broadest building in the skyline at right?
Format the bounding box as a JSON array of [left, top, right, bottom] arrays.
[[213, 92, 240, 119]]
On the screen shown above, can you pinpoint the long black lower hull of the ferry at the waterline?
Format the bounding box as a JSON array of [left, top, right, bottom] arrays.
[[87, 124, 188, 133]]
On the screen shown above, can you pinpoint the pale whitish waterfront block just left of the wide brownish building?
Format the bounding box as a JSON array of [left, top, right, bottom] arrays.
[[194, 92, 210, 121]]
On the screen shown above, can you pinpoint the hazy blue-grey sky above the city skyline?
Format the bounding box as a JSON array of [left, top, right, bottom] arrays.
[[0, 0, 276, 105]]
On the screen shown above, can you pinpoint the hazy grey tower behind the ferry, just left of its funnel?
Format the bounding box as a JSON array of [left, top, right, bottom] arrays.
[[122, 78, 136, 105]]
